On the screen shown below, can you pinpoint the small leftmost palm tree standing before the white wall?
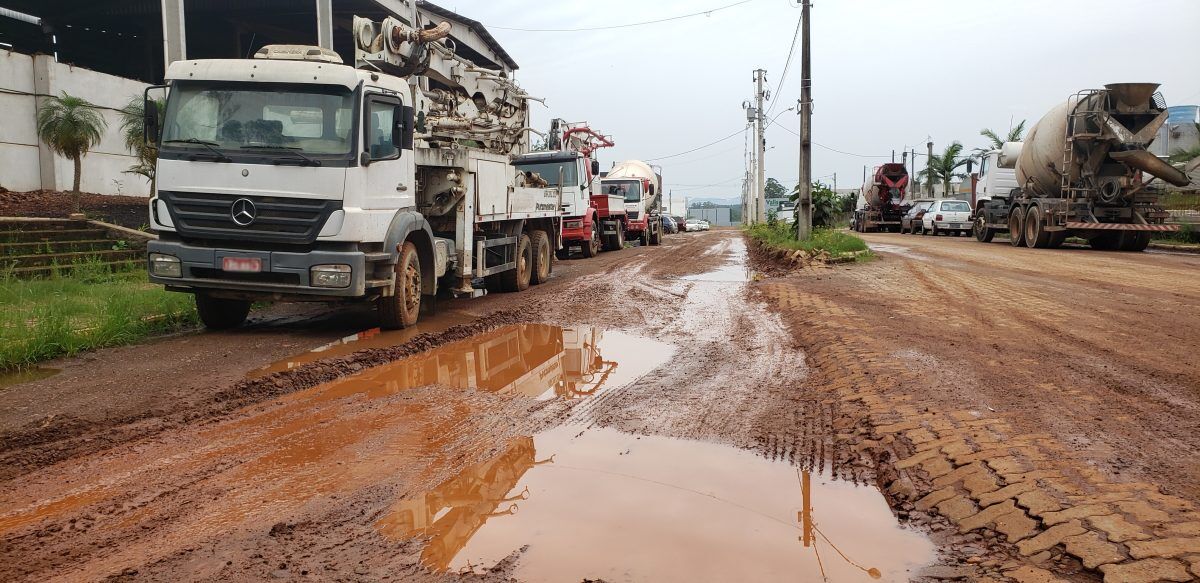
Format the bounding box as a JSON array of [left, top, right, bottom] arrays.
[[37, 91, 108, 211]]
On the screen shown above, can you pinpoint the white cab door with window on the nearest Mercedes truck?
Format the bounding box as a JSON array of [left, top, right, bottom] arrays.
[[360, 92, 415, 209]]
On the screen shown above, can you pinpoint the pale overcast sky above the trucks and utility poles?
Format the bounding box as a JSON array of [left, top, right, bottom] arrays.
[[453, 0, 1200, 198]]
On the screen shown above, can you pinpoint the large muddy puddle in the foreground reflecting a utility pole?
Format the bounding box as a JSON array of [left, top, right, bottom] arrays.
[[377, 426, 934, 582]]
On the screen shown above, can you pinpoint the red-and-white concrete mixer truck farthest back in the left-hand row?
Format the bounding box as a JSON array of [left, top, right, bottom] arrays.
[[600, 160, 662, 247]]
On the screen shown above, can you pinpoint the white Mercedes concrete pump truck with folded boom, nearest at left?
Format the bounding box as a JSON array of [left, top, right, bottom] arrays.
[[145, 10, 563, 329]]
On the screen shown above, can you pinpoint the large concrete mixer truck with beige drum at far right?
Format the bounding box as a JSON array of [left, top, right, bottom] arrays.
[[973, 83, 1188, 251]]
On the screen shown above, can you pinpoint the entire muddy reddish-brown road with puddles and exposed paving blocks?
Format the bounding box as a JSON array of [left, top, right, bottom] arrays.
[[0, 232, 1200, 582]]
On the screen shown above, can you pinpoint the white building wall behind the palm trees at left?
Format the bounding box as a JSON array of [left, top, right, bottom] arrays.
[[0, 52, 150, 196]]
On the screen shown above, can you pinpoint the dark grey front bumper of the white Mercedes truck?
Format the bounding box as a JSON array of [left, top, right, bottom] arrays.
[[146, 240, 367, 297]]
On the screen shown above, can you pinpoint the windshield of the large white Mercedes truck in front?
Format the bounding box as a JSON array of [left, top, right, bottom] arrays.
[[162, 83, 354, 156]]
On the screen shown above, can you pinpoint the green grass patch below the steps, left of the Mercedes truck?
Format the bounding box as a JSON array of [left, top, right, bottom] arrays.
[[0, 265, 198, 371]]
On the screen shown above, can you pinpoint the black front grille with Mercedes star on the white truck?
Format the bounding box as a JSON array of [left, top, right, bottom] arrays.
[[158, 191, 342, 245]]
